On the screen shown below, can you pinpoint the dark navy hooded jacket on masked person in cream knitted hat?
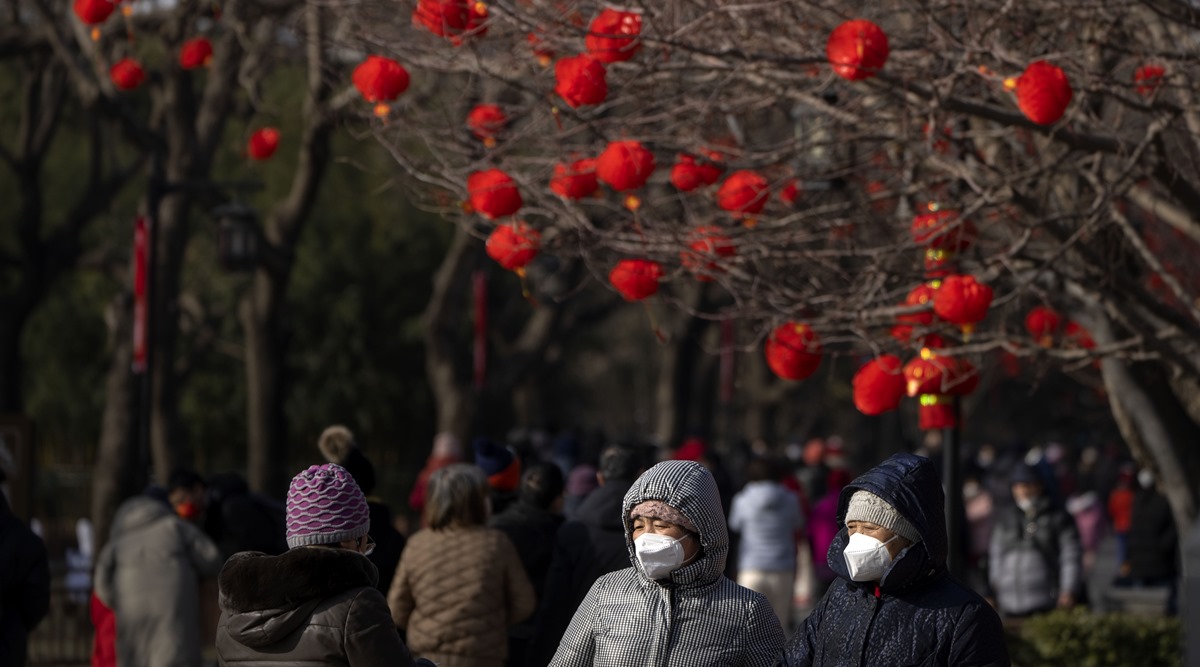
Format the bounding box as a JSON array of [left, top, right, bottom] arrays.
[[784, 453, 1009, 667]]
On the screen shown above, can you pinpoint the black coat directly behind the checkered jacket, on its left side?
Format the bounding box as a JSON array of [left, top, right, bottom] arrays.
[[528, 480, 631, 667]]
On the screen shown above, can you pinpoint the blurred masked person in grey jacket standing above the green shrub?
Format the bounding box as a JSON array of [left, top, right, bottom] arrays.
[[988, 463, 1084, 618]]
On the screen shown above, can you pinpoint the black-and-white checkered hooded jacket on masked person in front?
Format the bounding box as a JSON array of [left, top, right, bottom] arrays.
[[551, 461, 784, 667]]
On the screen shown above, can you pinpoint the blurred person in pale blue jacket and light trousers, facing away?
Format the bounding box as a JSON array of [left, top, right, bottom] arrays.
[[730, 458, 804, 629]]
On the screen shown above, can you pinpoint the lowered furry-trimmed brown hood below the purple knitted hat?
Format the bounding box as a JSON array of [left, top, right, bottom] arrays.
[[217, 547, 379, 647]]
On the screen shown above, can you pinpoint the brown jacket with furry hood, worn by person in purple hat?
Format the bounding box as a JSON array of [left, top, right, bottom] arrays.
[[217, 547, 413, 667]]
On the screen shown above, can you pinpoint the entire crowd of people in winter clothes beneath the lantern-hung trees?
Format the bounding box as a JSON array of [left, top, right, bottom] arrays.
[[0, 426, 1178, 667]]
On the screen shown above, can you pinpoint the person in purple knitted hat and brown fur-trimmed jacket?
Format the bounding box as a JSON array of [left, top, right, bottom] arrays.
[[216, 463, 413, 667]]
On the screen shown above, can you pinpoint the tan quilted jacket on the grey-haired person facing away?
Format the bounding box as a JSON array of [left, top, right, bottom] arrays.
[[388, 527, 536, 667]]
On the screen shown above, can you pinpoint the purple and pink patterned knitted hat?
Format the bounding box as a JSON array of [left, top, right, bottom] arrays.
[[287, 463, 371, 548]]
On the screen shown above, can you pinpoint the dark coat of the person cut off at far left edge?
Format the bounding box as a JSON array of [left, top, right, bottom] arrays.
[[0, 493, 50, 667]]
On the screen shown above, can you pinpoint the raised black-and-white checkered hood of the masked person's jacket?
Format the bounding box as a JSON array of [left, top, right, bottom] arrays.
[[622, 461, 730, 585]]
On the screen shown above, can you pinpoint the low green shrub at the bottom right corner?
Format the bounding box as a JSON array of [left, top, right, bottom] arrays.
[[1009, 608, 1182, 667]]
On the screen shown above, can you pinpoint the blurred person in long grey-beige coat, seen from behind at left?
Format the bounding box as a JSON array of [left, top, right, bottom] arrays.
[[95, 473, 224, 667]]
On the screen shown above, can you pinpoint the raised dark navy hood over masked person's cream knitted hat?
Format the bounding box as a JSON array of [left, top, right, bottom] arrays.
[[826, 453, 947, 591]]
